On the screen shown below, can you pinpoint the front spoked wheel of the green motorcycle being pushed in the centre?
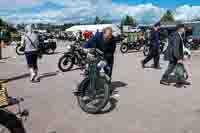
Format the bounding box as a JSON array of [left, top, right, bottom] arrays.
[[77, 78, 110, 114]]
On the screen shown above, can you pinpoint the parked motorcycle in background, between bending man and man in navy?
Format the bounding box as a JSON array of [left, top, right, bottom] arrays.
[[120, 39, 145, 54]]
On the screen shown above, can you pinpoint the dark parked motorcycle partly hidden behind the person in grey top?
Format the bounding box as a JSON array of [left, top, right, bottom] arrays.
[[16, 35, 57, 55]]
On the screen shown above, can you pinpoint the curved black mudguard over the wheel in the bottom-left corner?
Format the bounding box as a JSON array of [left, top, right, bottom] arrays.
[[0, 109, 25, 133]]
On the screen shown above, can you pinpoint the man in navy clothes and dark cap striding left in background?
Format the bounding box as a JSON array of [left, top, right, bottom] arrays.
[[141, 22, 160, 69]]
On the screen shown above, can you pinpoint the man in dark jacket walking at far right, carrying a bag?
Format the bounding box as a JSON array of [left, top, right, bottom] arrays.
[[160, 24, 190, 85]]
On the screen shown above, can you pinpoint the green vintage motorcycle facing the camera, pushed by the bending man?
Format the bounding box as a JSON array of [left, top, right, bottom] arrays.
[[74, 49, 111, 114]]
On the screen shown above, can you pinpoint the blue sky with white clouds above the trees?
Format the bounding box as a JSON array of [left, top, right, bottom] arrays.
[[0, 0, 200, 24]]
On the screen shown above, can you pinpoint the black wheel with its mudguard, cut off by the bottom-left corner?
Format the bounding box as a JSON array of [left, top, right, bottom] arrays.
[[0, 111, 25, 133]]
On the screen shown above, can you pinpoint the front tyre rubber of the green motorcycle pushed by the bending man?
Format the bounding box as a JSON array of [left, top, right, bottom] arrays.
[[77, 77, 110, 114]]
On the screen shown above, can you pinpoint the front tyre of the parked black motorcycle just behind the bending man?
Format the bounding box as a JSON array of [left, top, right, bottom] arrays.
[[58, 55, 74, 72]]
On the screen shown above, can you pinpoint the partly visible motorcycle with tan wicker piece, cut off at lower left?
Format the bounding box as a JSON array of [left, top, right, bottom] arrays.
[[0, 81, 29, 133]]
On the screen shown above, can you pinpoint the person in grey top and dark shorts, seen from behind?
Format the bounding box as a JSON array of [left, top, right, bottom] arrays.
[[22, 25, 39, 82]]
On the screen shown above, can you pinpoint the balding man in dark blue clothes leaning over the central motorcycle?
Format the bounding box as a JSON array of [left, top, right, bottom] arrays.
[[83, 27, 116, 78]]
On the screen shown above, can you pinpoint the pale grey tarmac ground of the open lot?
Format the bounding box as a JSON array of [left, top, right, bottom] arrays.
[[0, 43, 200, 133]]
